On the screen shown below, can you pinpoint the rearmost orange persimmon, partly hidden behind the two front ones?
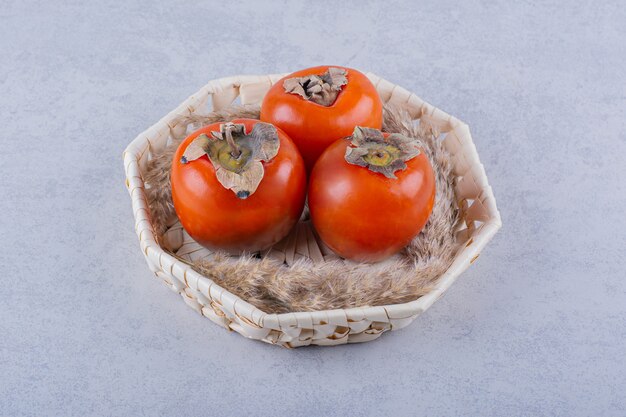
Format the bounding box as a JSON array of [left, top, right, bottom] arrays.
[[261, 66, 383, 172]]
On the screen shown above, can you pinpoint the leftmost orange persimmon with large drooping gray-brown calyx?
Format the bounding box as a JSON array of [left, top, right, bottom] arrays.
[[171, 119, 306, 252]]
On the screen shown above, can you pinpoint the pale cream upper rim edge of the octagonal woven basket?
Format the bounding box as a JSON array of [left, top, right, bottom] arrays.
[[123, 73, 502, 329]]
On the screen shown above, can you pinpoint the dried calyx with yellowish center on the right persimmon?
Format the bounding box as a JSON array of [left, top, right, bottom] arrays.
[[345, 126, 420, 178]]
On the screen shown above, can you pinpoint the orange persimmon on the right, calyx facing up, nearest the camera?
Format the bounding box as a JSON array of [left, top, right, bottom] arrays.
[[309, 127, 435, 262]]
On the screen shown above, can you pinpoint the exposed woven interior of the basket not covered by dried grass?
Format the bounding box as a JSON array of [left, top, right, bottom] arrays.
[[139, 77, 498, 265]]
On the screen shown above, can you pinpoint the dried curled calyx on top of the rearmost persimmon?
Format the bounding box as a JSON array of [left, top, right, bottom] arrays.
[[283, 67, 348, 107]]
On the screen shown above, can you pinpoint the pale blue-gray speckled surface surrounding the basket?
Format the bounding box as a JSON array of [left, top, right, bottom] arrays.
[[0, 0, 626, 417]]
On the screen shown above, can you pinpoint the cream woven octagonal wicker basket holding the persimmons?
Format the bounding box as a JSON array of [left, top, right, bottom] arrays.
[[123, 73, 501, 347]]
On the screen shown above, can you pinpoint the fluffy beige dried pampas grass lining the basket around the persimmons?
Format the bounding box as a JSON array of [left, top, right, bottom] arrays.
[[144, 106, 459, 313]]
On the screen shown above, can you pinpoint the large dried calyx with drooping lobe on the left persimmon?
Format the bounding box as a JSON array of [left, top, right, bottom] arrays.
[[181, 122, 280, 199]]
